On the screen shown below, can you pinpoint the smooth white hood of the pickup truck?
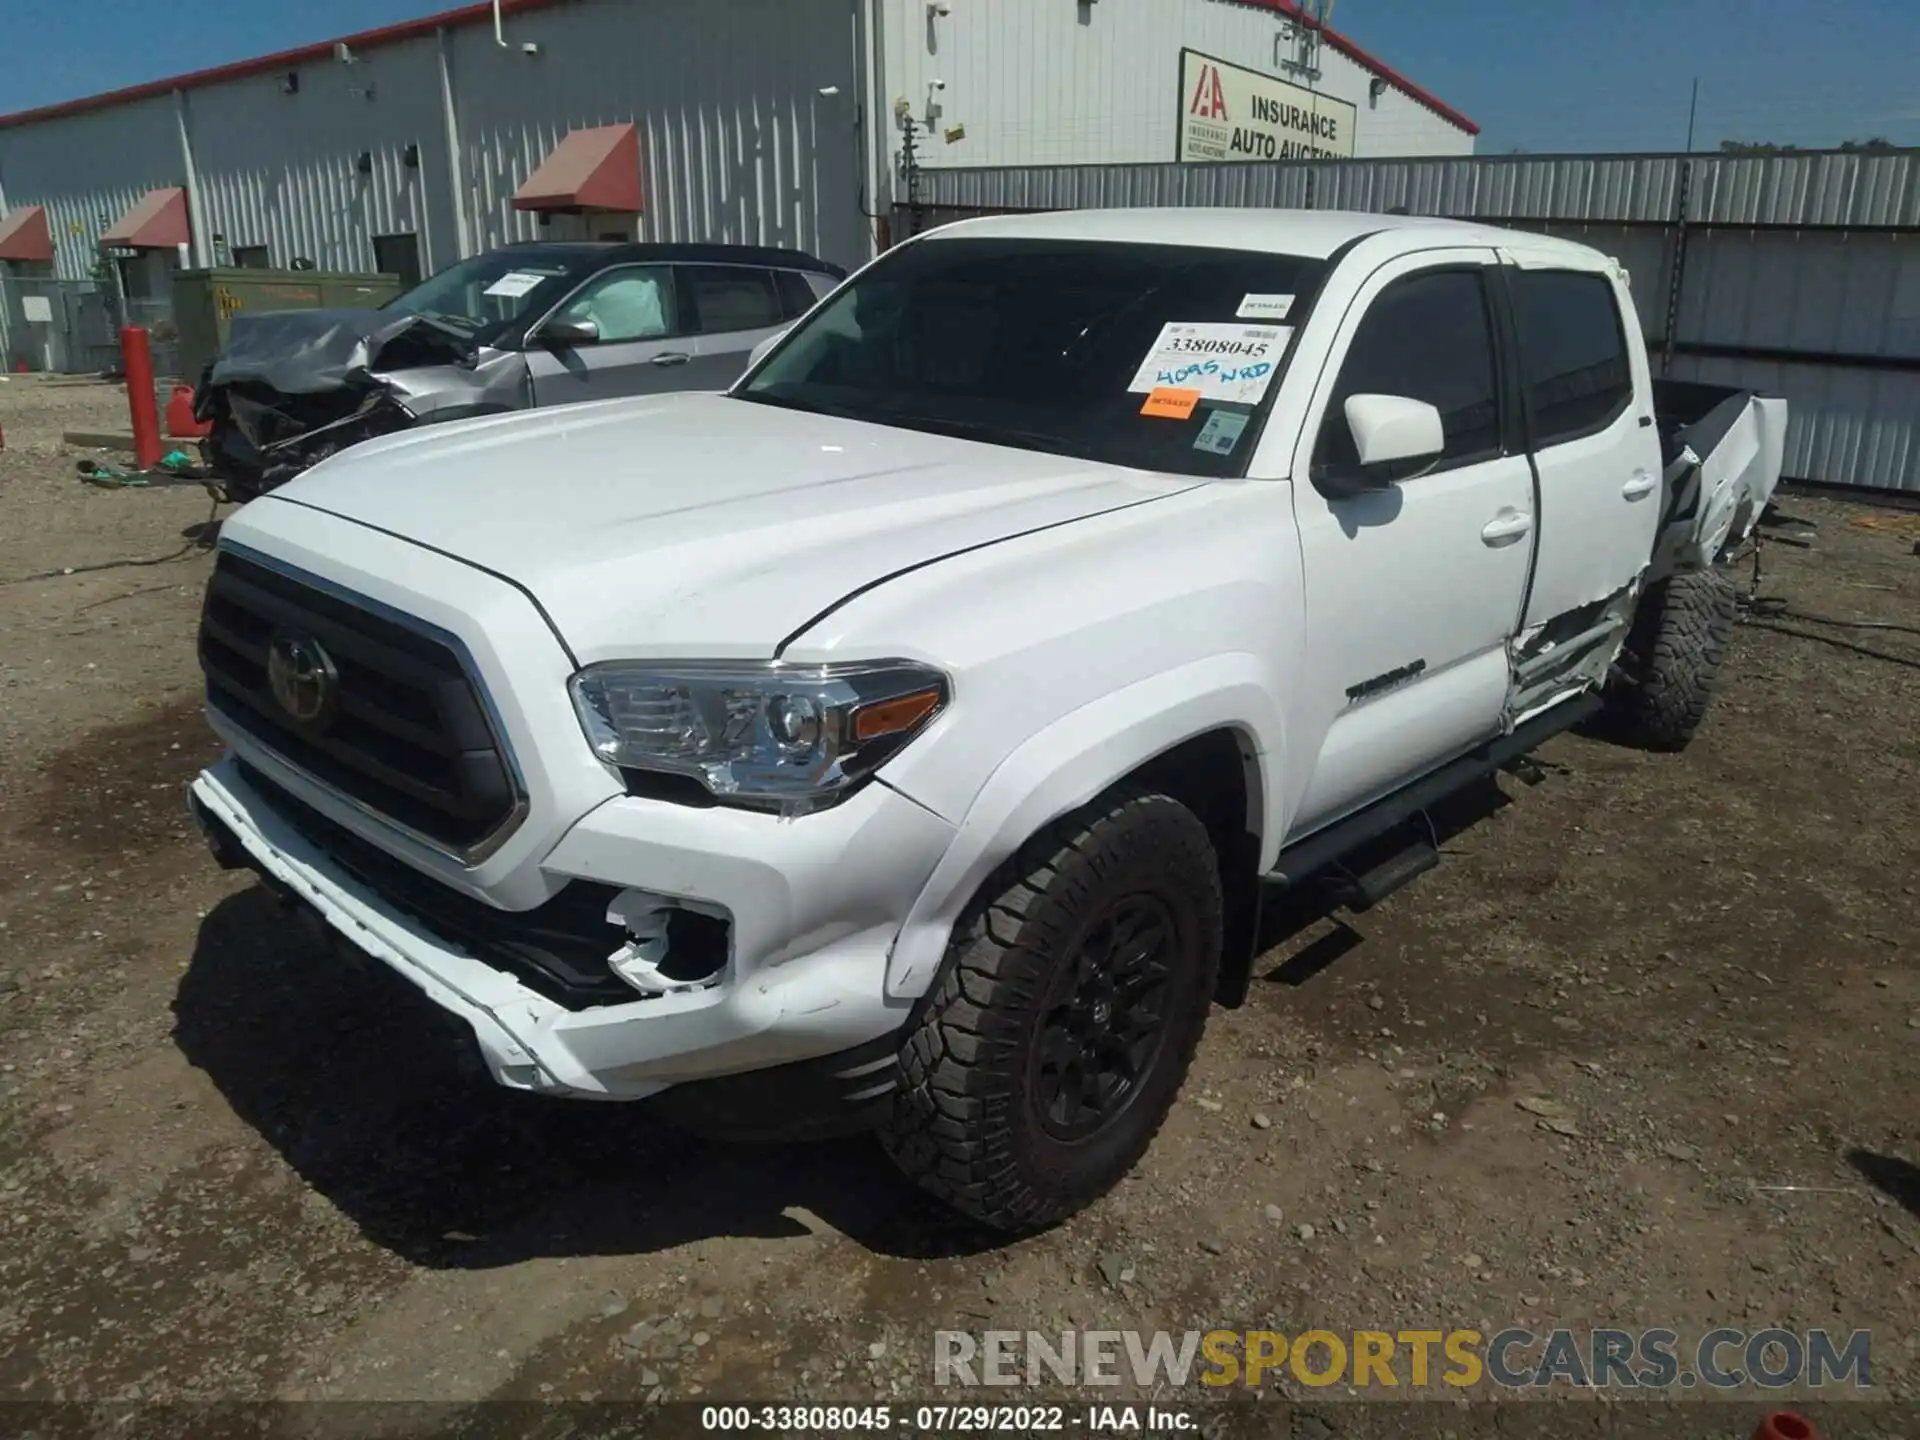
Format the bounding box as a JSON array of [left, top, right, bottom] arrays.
[[270, 394, 1202, 664]]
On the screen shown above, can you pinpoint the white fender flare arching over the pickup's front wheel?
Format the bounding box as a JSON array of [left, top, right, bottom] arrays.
[[887, 653, 1283, 1000]]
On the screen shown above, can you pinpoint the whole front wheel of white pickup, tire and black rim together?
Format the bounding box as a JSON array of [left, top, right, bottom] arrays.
[[881, 787, 1223, 1233]]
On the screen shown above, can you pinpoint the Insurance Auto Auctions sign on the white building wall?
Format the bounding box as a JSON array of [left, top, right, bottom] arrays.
[[1179, 50, 1359, 161]]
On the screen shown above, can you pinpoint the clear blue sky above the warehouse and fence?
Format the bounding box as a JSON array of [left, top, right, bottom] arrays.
[[0, 0, 1920, 154]]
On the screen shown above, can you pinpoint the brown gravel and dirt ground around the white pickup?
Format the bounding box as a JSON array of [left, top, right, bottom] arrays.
[[0, 378, 1920, 1436]]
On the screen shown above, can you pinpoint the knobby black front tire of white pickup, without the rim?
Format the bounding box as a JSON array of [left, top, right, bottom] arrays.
[[881, 787, 1221, 1233]]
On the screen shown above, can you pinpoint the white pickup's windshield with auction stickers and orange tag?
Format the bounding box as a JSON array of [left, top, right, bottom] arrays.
[[733, 238, 1325, 476]]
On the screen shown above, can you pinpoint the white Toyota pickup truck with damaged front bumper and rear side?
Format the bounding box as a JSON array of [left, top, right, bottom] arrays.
[[192, 209, 1786, 1229]]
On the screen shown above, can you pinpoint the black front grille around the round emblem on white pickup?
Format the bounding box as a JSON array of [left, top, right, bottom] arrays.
[[200, 553, 516, 849]]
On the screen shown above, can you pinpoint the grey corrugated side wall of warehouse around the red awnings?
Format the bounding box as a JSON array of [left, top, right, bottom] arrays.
[[0, 0, 872, 289]]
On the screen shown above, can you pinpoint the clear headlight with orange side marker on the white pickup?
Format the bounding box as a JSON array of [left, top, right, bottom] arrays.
[[568, 660, 948, 812]]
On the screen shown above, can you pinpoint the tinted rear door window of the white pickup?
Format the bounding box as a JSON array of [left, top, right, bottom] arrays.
[[1507, 269, 1634, 449]]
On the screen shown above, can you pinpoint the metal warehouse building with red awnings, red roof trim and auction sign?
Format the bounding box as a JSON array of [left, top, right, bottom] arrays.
[[0, 0, 1475, 298]]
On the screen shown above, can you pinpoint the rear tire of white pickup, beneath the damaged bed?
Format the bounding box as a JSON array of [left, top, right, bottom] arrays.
[[1603, 570, 1740, 751]]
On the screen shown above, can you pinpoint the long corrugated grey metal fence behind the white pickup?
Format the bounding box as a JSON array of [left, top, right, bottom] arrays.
[[889, 150, 1920, 492]]
